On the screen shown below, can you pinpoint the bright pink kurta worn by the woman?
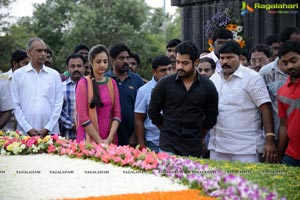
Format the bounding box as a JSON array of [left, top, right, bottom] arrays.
[[76, 78, 121, 144]]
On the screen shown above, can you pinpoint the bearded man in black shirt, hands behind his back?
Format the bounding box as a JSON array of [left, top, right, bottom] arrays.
[[149, 41, 218, 157]]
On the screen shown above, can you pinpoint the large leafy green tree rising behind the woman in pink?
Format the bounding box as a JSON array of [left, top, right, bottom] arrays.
[[33, 0, 149, 70]]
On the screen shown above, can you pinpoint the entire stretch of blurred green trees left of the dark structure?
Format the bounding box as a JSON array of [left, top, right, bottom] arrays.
[[0, 0, 181, 79]]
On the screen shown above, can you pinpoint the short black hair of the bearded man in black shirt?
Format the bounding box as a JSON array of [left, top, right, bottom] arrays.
[[175, 41, 200, 62]]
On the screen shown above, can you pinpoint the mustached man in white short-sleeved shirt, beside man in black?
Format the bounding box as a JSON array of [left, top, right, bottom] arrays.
[[208, 41, 277, 162]]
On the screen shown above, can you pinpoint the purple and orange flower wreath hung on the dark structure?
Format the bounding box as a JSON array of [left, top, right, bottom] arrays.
[[204, 8, 246, 51]]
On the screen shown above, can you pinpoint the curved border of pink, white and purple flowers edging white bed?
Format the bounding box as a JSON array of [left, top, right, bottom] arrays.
[[0, 131, 286, 200]]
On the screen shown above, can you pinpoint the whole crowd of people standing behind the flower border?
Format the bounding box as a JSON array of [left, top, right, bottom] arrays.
[[0, 26, 300, 166]]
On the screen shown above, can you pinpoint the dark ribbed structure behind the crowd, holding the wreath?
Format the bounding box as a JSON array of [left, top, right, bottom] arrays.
[[171, 0, 300, 50]]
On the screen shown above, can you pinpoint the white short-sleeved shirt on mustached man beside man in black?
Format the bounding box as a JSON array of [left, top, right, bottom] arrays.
[[208, 65, 271, 154]]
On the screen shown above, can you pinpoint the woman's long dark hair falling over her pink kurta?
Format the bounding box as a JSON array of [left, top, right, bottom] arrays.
[[88, 44, 109, 108]]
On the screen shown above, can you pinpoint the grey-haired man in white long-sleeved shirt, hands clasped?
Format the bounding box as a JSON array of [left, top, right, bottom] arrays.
[[11, 38, 63, 137]]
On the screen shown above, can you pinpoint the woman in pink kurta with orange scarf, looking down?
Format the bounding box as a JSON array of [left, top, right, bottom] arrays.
[[76, 45, 121, 144]]
